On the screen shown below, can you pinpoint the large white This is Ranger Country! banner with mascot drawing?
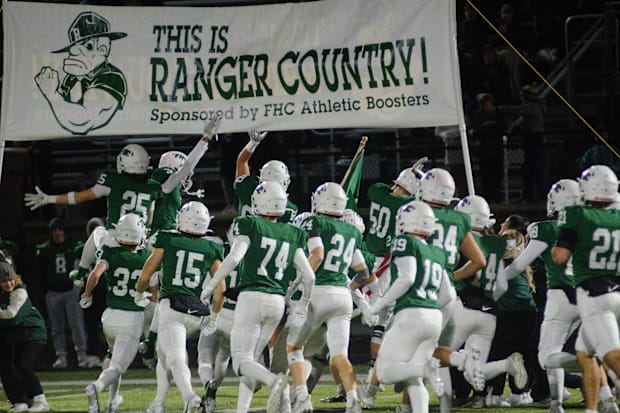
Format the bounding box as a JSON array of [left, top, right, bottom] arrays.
[[0, 0, 461, 141]]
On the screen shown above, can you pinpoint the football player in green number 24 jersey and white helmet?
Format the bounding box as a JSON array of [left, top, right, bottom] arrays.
[[287, 182, 370, 413]]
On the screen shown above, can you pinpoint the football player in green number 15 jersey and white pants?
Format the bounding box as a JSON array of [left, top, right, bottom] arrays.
[[136, 201, 224, 413]]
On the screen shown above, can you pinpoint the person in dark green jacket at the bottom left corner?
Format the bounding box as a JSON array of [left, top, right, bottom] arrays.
[[0, 261, 49, 412]]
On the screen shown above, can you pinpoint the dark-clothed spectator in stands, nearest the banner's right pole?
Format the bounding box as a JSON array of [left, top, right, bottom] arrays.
[[469, 93, 506, 202]]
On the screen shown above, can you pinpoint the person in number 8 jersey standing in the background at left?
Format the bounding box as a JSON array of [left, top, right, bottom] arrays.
[[37, 217, 88, 369]]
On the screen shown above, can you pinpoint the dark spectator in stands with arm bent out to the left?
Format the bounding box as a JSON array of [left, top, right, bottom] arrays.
[[497, 83, 551, 201]]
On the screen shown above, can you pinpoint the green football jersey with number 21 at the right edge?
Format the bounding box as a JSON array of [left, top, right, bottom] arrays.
[[558, 206, 620, 285]]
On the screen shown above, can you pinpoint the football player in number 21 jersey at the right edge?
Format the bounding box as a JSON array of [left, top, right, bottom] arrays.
[[551, 165, 620, 411]]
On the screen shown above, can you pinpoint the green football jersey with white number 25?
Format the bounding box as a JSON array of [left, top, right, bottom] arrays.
[[97, 171, 163, 228]]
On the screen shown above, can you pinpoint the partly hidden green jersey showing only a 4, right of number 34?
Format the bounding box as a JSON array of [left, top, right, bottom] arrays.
[[455, 232, 506, 300]]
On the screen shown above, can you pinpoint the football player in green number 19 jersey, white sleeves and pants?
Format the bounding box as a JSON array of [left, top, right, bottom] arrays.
[[371, 201, 450, 412]]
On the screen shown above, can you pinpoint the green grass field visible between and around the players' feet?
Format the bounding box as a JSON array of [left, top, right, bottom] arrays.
[[0, 366, 584, 413]]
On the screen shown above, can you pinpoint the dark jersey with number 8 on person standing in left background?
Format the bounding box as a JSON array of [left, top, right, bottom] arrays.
[[37, 240, 83, 292]]
